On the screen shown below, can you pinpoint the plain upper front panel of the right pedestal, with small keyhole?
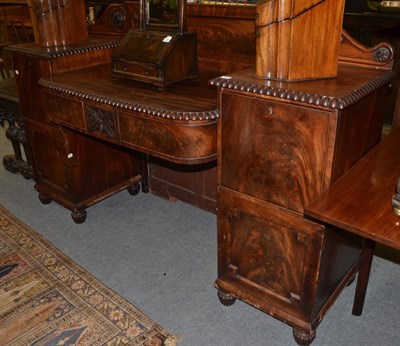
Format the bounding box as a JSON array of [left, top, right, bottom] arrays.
[[218, 92, 335, 213]]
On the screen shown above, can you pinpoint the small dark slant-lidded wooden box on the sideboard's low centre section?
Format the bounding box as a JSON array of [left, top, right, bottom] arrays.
[[113, 30, 198, 87]]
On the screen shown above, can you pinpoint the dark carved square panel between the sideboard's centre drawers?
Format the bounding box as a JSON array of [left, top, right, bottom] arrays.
[[85, 105, 115, 138]]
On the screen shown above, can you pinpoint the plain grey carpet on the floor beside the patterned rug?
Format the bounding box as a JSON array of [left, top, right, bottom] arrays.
[[0, 129, 400, 346]]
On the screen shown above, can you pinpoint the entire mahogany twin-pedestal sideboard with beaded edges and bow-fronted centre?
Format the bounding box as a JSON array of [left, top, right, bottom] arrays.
[[4, 2, 395, 345]]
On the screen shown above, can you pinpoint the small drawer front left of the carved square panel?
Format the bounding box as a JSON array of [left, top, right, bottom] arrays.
[[43, 92, 86, 130]]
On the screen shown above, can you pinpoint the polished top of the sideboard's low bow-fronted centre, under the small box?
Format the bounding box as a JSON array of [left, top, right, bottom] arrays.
[[40, 64, 218, 121]]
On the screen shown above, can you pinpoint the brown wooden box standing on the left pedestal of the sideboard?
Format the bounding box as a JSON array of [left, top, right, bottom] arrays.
[[29, 0, 88, 47]]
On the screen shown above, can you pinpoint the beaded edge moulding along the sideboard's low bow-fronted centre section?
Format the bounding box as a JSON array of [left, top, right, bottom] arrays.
[[39, 80, 219, 121]]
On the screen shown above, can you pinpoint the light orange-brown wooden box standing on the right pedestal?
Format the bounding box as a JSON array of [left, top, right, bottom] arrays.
[[255, 0, 344, 81]]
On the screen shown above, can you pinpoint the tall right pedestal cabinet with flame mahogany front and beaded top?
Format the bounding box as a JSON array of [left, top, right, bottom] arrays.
[[211, 66, 393, 345]]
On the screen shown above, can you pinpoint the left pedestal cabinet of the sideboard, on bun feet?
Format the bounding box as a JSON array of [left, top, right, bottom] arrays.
[[9, 39, 147, 223]]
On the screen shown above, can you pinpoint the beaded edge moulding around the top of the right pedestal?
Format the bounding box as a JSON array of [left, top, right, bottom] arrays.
[[209, 71, 396, 109]]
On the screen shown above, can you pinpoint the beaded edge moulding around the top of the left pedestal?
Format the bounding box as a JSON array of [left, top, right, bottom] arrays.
[[6, 40, 121, 60]]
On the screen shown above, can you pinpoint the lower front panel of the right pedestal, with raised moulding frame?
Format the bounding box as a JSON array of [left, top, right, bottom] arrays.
[[218, 189, 324, 314]]
